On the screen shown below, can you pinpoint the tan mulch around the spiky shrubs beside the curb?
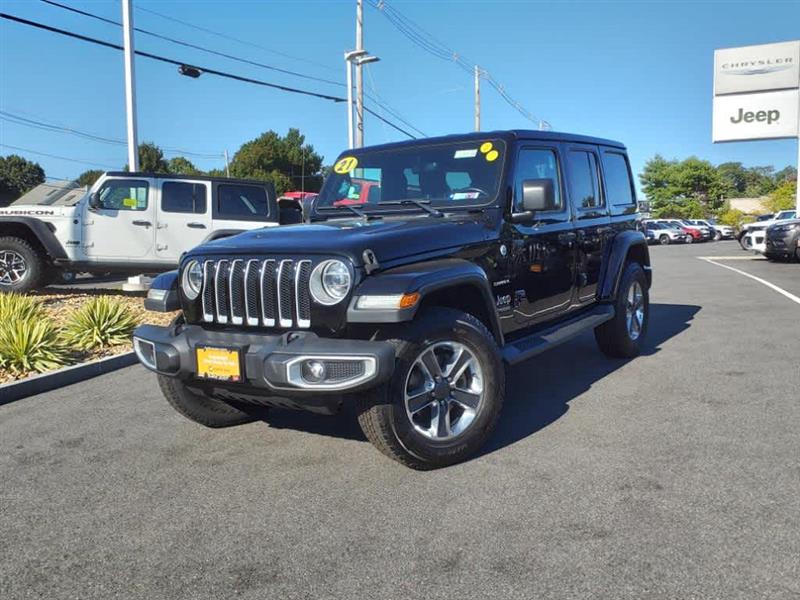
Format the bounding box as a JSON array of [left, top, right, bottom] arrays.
[[0, 288, 177, 384]]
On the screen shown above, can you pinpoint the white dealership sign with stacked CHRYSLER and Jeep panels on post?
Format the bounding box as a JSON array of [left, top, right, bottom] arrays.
[[712, 40, 800, 213]]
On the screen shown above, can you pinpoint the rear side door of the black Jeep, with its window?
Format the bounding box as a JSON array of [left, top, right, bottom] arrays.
[[567, 145, 611, 304]]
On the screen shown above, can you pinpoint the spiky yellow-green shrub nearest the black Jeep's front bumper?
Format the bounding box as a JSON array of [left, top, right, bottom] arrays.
[[64, 296, 139, 350]]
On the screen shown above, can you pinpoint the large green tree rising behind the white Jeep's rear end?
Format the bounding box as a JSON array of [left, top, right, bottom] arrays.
[[230, 128, 322, 194]]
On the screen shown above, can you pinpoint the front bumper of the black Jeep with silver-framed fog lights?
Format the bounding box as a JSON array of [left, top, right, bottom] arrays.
[[133, 325, 395, 397]]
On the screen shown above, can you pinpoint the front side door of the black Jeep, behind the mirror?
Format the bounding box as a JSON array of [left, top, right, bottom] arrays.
[[509, 144, 575, 328]]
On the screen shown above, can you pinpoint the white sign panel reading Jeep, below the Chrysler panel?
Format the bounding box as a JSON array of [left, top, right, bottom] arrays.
[[713, 90, 800, 142]]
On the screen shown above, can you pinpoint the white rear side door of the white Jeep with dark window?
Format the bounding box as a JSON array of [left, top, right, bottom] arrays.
[[156, 179, 211, 263]]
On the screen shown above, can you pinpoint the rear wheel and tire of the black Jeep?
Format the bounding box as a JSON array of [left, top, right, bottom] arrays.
[[594, 262, 650, 358]]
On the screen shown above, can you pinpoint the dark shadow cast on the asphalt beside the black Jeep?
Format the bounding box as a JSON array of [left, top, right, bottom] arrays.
[[481, 304, 700, 455]]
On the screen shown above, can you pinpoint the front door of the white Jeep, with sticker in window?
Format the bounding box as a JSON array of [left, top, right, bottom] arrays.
[[83, 178, 155, 263]]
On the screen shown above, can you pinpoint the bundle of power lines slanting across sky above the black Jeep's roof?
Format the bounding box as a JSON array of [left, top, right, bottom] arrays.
[[367, 0, 550, 129]]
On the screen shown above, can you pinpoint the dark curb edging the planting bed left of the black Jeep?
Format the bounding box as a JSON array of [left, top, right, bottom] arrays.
[[0, 351, 138, 406]]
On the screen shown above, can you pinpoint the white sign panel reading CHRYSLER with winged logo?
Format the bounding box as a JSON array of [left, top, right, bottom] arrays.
[[714, 41, 800, 96]]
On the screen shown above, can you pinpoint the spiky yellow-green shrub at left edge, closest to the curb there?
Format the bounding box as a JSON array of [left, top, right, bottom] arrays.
[[0, 317, 69, 374]]
